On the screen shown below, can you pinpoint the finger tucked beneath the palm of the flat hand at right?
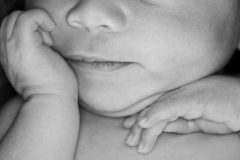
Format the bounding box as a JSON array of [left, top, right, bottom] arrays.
[[164, 118, 201, 134]]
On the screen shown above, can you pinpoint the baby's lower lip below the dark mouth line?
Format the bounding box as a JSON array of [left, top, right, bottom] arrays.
[[71, 60, 132, 71]]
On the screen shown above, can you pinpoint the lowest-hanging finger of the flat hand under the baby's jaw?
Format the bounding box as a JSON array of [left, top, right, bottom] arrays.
[[137, 121, 168, 154]]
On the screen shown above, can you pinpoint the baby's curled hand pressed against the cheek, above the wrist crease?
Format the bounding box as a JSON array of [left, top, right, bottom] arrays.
[[0, 9, 77, 100]]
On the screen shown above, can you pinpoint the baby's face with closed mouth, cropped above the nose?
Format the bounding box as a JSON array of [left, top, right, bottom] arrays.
[[27, 0, 237, 116]]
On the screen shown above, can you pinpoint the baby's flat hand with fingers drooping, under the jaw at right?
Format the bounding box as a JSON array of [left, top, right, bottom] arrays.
[[124, 76, 240, 153]]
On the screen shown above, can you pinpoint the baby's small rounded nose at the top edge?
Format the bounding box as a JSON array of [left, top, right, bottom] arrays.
[[67, 0, 126, 33]]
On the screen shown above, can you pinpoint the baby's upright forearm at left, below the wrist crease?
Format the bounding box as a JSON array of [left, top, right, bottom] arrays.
[[0, 95, 79, 160]]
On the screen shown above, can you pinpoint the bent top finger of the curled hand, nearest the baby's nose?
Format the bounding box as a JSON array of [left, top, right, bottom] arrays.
[[13, 9, 55, 41]]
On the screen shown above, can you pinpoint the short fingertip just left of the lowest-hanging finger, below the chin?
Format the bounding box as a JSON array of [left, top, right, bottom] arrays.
[[125, 123, 142, 147]]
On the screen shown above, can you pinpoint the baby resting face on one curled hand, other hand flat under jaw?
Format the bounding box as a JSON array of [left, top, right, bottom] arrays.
[[0, 0, 240, 160]]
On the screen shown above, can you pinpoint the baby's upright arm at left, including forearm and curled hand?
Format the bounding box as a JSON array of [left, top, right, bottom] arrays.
[[0, 9, 79, 160]]
